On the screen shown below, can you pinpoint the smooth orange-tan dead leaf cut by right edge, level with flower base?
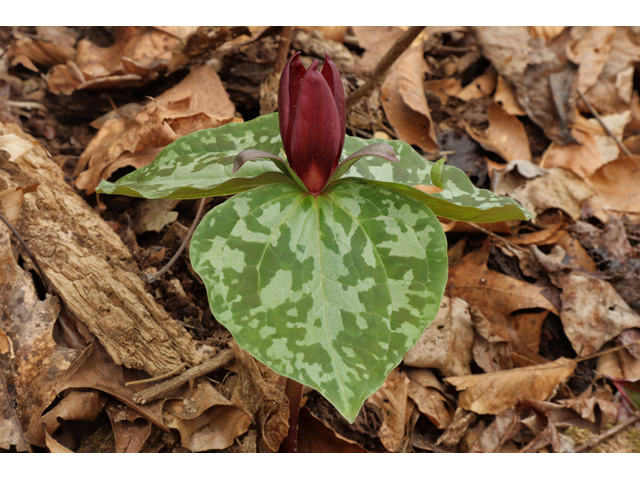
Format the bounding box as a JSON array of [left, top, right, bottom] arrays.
[[587, 155, 640, 223]]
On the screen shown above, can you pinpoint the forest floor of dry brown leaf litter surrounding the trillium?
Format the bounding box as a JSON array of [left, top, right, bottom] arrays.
[[0, 27, 640, 452]]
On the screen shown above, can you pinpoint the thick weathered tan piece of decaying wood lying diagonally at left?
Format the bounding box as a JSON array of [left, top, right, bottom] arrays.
[[0, 123, 201, 376]]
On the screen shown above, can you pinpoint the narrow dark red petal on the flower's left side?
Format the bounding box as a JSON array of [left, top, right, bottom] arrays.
[[278, 52, 306, 155]]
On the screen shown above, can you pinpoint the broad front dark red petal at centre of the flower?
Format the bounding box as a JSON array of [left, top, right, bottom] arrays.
[[287, 60, 344, 194]]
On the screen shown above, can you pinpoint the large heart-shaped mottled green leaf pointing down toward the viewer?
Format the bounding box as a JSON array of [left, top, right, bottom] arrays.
[[191, 181, 447, 421]]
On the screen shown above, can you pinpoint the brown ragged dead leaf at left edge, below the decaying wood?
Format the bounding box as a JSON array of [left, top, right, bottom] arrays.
[[0, 223, 79, 447]]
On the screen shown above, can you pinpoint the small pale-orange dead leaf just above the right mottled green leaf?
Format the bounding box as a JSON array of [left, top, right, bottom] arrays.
[[465, 103, 531, 162]]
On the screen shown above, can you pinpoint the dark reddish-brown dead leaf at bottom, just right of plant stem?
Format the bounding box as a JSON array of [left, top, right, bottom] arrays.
[[297, 407, 366, 453]]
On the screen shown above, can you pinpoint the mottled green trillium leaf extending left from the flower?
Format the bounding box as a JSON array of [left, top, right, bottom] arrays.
[[96, 114, 288, 198]]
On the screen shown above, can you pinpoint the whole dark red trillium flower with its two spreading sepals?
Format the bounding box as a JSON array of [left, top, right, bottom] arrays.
[[234, 52, 398, 195]]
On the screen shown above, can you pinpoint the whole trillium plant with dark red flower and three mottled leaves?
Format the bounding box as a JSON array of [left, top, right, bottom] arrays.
[[98, 53, 533, 422]]
